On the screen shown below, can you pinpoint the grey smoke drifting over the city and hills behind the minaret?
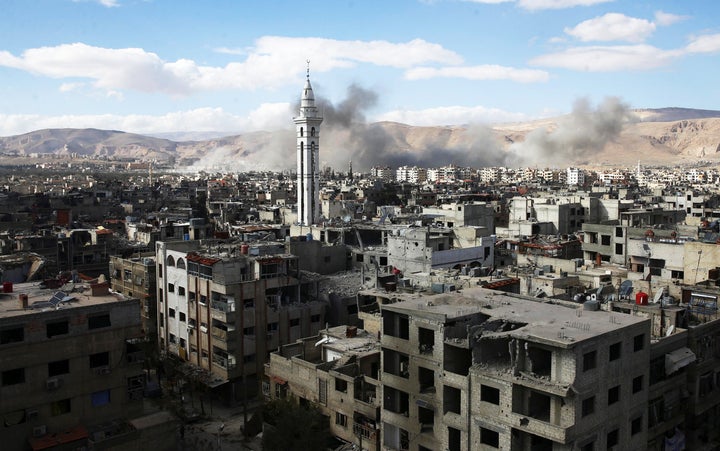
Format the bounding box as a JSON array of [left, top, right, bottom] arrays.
[[191, 84, 633, 170]]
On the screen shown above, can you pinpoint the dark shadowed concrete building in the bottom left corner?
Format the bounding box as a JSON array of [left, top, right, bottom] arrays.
[[0, 283, 153, 450]]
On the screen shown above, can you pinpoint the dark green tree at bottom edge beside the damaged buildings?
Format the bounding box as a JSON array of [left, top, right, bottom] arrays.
[[263, 399, 332, 451]]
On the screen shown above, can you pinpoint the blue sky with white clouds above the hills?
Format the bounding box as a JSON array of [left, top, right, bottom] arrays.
[[0, 0, 720, 136]]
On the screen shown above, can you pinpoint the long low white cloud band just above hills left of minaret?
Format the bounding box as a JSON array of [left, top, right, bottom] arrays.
[[0, 103, 292, 136]]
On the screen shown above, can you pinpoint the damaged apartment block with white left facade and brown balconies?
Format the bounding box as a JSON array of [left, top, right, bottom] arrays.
[[156, 241, 327, 399]]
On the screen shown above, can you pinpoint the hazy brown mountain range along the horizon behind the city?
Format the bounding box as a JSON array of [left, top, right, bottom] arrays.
[[0, 105, 720, 171]]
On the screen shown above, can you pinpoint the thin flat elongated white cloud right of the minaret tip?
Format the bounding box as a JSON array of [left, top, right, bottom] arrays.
[[405, 64, 549, 83]]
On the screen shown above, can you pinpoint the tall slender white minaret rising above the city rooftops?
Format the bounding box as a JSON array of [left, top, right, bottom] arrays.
[[293, 61, 322, 226]]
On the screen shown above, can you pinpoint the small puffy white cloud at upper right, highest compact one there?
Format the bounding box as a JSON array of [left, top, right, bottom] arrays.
[[565, 13, 655, 42]]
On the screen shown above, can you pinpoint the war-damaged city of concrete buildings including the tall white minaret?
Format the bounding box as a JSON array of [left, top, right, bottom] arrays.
[[0, 76, 720, 451]]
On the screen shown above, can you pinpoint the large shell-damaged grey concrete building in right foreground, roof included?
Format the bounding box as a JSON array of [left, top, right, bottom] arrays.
[[379, 288, 650, 451]]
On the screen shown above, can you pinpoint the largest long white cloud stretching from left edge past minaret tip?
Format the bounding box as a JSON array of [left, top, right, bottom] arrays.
[[0, 36, 462, 95]]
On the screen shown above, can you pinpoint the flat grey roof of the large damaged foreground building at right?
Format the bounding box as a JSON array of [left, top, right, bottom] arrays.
[[382, 287, 649, 347]]
